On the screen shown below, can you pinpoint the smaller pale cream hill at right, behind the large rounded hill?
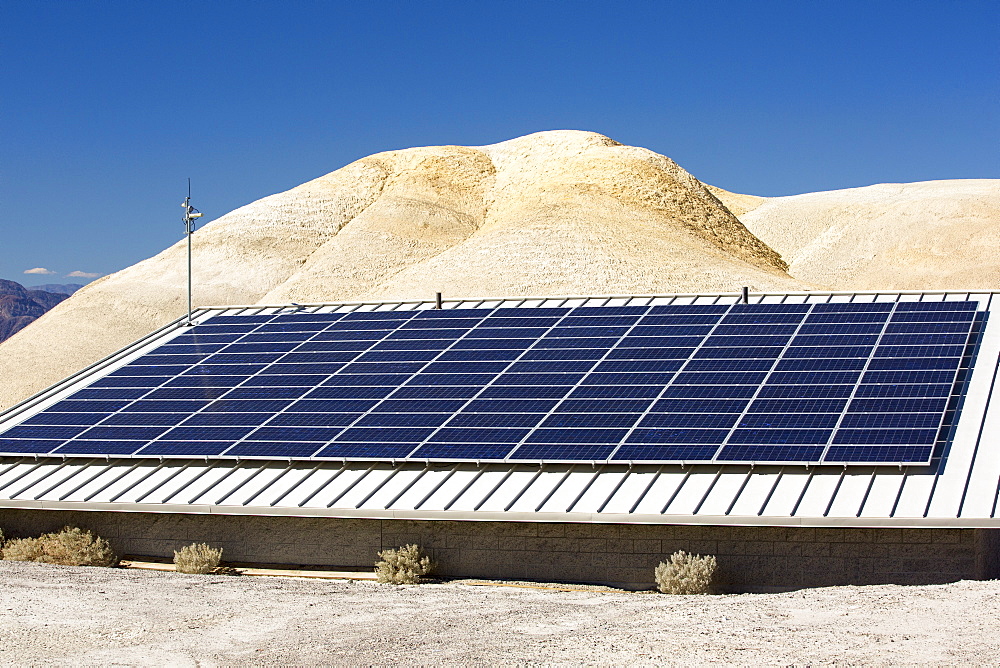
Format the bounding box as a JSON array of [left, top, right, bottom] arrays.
[[740, 179, 1000, 290]]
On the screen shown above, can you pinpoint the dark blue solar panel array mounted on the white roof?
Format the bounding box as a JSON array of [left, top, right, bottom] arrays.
[[0, 301, 977, 464]]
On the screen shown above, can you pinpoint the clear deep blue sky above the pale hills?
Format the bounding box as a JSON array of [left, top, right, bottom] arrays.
[[0, 0, 1000, 285]]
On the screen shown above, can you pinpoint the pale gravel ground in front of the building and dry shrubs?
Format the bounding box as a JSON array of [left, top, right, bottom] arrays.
[[0, 561, 1000, 665]]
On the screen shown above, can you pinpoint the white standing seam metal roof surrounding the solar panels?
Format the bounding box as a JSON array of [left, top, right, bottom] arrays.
[[0, 290, 1000, 528]]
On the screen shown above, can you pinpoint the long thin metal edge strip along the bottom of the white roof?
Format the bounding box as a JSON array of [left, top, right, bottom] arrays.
[[0, 499, 1000, 529]]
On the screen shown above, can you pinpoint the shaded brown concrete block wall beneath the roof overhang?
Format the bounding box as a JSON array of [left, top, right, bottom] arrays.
[[0, 510, 1000, 591]]
